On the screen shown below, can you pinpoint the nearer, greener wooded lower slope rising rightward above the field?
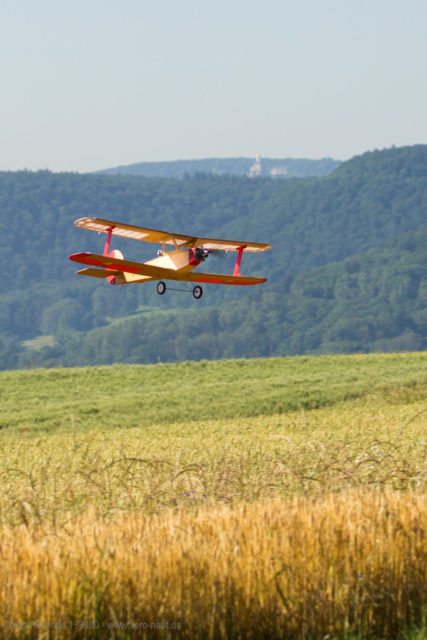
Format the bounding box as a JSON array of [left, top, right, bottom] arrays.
[[19, 232, 427, 366]]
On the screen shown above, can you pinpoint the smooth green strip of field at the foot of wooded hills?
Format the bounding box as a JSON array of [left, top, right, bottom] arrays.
[[0, 353, 427, 433]]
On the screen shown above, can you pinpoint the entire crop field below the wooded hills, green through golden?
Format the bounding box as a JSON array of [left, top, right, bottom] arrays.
[[0, 353, 427, 639]]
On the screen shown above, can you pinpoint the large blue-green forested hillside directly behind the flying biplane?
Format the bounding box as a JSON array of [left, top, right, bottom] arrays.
[[0, 145, 427, 368]]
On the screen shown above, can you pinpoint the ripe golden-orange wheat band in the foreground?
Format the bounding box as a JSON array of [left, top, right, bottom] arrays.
[[0, 489, 427, 638]]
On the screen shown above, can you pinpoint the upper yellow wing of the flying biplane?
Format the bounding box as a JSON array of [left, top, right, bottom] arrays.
[[74, 218, 272, 252]]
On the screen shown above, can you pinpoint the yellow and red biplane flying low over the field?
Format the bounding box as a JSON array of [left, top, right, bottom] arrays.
[[69, 218, 271, 299]]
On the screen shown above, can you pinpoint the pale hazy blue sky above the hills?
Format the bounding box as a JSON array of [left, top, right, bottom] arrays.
[[0, 0, 427, 172]]
